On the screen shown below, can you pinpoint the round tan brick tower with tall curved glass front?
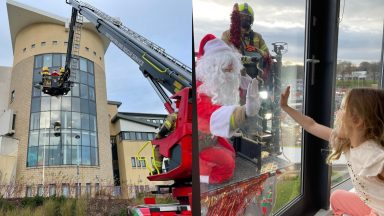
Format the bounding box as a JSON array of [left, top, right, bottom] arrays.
[[2, 1, 113, 195]]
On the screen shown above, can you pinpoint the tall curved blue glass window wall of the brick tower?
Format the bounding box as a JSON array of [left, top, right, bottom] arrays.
[[27, 54, 98, 167]]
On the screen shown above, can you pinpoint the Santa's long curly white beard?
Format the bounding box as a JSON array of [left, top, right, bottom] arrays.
[[196, 51, 242, 105]]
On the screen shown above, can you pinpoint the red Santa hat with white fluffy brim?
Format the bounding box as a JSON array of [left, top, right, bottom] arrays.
[[197, 34, 232, 58]]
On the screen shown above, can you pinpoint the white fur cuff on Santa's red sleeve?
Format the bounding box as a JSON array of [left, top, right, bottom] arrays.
[[209, 105, 238, 138]]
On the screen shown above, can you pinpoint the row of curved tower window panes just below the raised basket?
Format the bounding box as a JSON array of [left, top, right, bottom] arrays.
[[31, 97, 96, 115]]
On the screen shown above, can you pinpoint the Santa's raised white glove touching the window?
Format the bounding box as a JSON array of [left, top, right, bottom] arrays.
[[244, 79, 260, 117]]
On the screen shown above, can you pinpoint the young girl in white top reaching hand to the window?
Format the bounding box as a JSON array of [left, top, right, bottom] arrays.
[[280, 86, 384, 216]]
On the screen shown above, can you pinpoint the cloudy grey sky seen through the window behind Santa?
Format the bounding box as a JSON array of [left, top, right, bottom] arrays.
[[193, 0, 384, 64]]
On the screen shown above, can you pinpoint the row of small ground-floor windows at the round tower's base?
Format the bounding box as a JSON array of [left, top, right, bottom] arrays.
[[25, 183, 100, 197]]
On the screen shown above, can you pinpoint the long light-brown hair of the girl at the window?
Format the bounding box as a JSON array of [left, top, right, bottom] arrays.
[[327, 88, 384, 163]]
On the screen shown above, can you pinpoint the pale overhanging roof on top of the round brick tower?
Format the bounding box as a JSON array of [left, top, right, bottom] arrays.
[[7, 0, 110, 51]]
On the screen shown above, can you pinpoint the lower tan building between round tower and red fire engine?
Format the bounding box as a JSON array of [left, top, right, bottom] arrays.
[[108, 101, 172, 198]]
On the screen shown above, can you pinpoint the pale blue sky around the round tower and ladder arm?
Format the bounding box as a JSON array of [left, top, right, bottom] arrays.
[[0, 0, 192, 113]]
